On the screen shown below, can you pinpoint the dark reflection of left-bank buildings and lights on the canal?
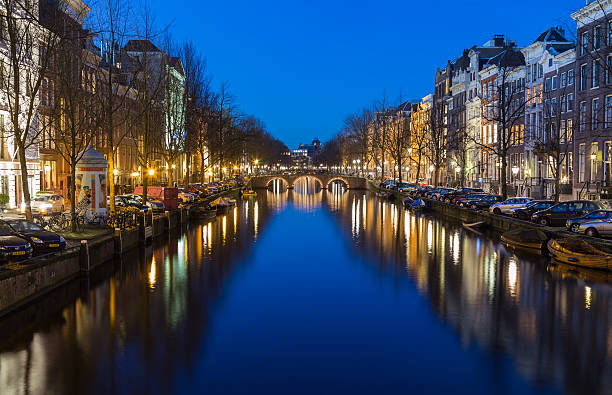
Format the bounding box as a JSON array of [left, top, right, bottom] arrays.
[[0, 196, 286, 394]]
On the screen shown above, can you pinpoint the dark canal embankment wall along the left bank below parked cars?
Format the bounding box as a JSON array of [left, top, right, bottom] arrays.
[[0, 189, 239, 316]]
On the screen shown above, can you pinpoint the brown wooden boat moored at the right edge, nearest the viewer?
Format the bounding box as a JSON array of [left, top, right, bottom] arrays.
[[548, 237, 612, 270]]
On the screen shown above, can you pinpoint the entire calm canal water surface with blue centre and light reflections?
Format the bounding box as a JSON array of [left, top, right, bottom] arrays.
[[0, 181, 612, 394]]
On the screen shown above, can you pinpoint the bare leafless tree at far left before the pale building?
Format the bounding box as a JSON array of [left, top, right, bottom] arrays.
[[0, 0, 74, 219]]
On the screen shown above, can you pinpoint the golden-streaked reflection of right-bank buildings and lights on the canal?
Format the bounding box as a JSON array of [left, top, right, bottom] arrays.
[[327, 192, 612, 393]]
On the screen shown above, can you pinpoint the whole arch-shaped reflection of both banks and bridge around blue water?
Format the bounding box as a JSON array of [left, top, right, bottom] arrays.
[[0, 189, 612, 394]]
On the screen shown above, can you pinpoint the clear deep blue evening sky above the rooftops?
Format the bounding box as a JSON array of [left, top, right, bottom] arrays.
[[149, 0, 584, 147]]
